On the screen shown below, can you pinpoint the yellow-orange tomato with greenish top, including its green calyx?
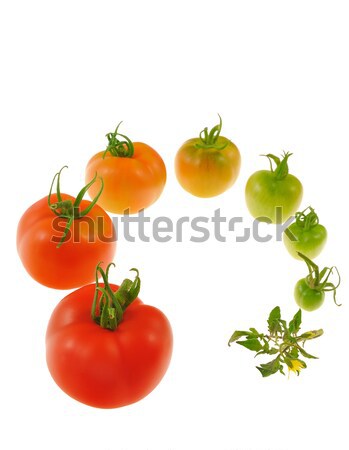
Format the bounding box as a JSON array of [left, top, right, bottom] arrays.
[[175, 117, 241, 197]]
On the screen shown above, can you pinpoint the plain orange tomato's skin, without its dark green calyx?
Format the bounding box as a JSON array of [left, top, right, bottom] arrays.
[[86, 142, 167, 214]]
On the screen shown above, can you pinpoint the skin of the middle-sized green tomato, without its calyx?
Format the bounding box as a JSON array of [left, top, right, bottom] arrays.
[[283, 222, 327, 259]]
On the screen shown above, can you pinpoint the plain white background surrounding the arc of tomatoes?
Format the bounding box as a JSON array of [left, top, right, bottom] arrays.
[[0, 0, 349, 450]]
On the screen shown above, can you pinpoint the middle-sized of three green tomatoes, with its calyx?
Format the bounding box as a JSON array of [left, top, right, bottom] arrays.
[[283, 206, 327, 259]]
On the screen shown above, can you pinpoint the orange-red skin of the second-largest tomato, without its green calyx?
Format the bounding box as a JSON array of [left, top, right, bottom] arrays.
[[17, 194, 116, 289]]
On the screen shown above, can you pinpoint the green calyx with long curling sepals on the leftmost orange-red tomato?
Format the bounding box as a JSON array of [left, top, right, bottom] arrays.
[[47, 166, 104, 248]]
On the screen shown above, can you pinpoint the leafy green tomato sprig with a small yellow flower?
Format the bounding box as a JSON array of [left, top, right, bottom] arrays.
[[228, 306, 323, 377]]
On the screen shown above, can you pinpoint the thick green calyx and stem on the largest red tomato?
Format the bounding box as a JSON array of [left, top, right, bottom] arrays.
[[91, 263, 141, 331]]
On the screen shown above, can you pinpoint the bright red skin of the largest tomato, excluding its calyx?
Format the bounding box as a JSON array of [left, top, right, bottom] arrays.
[[46, 284, 173, 408]]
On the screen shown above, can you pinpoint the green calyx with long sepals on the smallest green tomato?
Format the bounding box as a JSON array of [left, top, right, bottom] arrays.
[[297, 252, 341, 306]]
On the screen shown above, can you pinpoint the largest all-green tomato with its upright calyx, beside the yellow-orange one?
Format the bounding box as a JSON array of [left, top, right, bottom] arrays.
[[245, 153, 303, 223]]
